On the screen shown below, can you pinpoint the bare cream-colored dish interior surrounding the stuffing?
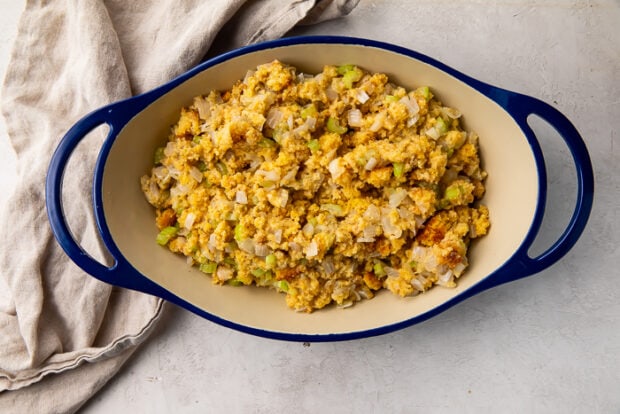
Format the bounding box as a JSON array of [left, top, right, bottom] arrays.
[[102, 44, 538, 335]]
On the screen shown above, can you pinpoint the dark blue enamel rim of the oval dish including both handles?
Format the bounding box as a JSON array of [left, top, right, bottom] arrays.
[[46, 36, 594, 342]]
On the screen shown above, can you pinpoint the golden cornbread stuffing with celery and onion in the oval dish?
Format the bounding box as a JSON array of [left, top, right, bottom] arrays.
[[141, 61, 489, 312]]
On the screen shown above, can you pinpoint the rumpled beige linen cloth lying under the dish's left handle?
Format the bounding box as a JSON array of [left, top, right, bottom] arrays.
[[0, 0, 359, 413]]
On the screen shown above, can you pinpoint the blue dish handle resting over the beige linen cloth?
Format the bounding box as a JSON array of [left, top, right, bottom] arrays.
[[45, 99, 141, 288]]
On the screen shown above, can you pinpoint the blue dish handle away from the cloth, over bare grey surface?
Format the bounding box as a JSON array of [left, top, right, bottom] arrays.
[[483, 89, 594, 289]]
